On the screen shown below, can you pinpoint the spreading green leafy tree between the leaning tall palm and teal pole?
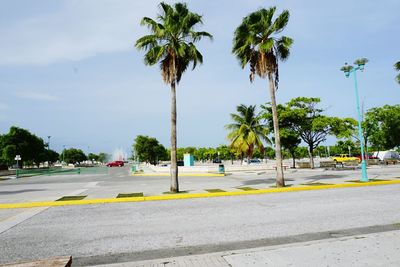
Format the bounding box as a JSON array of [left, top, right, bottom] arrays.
[[280, 97, 357, 168]]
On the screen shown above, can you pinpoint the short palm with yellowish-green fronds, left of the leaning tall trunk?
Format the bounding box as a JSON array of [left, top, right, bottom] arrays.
[[225, 104, 270, 163]]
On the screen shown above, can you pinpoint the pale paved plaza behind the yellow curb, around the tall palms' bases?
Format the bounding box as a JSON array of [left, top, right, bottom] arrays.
[[0, 166, 400, 204]]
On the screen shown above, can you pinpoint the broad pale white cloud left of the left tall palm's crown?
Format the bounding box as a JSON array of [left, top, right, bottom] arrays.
[[0, 0, 165, 65]]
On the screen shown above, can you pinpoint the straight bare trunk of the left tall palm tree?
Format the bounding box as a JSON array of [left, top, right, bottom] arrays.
[[170, 82, 179, 193]]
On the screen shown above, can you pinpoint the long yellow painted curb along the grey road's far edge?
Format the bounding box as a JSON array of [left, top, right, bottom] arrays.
[[0, 180, 400, 209]]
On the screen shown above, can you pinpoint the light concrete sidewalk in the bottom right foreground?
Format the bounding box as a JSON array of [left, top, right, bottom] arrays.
[[97, 231, 400, 267]]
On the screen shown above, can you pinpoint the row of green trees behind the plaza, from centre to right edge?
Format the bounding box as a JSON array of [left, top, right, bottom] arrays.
[[132, 102, 400, 170]]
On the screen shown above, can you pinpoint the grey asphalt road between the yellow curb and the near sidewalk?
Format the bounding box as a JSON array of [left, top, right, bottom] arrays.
[[0, 185, 400, 265]]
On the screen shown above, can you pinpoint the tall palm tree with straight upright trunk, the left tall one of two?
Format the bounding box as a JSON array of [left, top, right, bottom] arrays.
[[135, 2, 212, 192]]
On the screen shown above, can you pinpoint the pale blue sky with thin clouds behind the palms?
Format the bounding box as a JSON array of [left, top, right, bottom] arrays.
[[0, 0, 400, 156]]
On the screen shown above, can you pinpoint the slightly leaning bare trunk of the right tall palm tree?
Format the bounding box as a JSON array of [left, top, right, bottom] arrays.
[[268, 73, 285, 187]]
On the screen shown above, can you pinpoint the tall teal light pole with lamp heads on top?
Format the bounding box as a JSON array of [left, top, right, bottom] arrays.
[[341, 58, 368, 182]]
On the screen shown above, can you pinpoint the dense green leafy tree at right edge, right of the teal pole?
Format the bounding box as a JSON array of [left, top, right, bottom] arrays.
[[365, 105, 400, 150]]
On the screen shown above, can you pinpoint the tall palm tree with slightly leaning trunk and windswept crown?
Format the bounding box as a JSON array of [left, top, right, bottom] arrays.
[[232, 7, 293, 187]]
